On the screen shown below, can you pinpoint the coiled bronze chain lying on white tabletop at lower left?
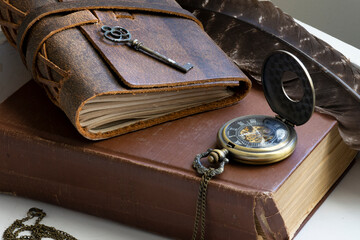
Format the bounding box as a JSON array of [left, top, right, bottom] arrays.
[[3, 208, 77, 240]]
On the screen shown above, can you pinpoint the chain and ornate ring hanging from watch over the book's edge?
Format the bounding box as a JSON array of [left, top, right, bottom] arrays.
[[192, 149, 229, 240]]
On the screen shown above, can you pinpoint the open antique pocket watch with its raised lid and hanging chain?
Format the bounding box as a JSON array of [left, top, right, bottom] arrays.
[[193, 51, 315, 239]]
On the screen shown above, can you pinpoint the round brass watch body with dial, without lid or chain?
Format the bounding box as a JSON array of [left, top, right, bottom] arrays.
[[218, 115, 297, 164]]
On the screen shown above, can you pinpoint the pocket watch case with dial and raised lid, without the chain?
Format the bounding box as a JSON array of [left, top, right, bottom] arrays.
[[218, 51, 315, 164]]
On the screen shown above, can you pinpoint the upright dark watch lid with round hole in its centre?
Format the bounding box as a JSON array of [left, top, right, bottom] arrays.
[[262, 51, 315, 125]]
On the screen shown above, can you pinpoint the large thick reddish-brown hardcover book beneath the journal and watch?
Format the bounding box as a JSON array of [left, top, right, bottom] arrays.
[[0, 79, 355, 239]]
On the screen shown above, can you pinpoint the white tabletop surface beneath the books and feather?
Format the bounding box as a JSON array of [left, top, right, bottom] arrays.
[[0, 21, 360, 240]]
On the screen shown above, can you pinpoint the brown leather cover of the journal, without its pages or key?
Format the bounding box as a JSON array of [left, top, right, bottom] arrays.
[[0, 0, 251, 139]]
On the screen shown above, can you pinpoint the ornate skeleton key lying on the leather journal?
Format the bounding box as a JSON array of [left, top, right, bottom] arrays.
[[101, 25, 194, 73]]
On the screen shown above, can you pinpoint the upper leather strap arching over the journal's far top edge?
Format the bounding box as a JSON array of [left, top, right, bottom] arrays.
[[16, 0, 202, 62]]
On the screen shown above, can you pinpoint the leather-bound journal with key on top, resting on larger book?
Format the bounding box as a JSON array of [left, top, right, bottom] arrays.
[[0, 0, 251, 140]]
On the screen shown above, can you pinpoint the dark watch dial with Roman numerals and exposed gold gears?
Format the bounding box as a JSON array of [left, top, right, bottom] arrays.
[[225, 116, 289, 148]]
